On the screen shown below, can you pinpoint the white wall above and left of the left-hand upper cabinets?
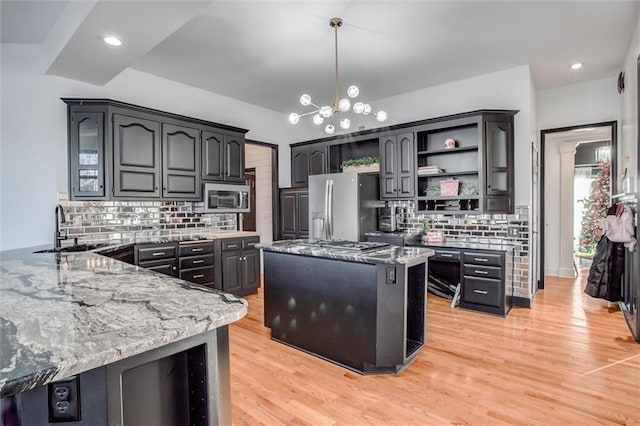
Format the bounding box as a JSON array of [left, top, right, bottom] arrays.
[[0, 44, 288, 250]]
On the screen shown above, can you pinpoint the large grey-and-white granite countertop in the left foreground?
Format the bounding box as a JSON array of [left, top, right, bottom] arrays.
[[0, 247, 247, 396]]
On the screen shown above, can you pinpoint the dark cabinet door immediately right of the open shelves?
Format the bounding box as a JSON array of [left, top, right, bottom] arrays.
[[485, 121, 511, 195]]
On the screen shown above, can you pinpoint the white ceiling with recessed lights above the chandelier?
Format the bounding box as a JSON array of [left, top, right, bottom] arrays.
[[0, 0, 640, 112]]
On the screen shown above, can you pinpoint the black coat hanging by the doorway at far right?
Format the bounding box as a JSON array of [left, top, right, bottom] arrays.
[[584, 205, 625, 302]]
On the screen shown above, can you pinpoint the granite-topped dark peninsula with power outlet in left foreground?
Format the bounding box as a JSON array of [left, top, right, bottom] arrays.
[[0, 248, 247, 426]]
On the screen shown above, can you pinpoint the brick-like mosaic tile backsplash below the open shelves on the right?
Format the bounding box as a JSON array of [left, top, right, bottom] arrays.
[[389, 201, 531, 299]]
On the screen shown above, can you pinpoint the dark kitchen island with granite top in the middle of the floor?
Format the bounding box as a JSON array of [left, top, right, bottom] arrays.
[[258, 240, 433, 374]]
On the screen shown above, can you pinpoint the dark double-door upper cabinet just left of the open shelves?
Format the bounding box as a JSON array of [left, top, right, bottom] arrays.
[[380, 133, 416, 200]]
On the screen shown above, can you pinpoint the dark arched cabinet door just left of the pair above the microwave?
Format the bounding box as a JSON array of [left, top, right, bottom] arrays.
[[162, 124, 201, 200]]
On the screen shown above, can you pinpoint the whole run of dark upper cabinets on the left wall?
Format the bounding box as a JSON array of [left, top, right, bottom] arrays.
[[63, 98, 246, 200]]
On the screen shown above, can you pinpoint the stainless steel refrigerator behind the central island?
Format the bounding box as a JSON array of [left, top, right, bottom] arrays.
[[309, 173, 384, 241]]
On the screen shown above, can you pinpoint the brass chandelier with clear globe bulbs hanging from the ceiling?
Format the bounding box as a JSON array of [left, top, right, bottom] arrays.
[[289, 18, 387, 135]]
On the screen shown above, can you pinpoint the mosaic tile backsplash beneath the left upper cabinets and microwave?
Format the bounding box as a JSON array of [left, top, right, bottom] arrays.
[[58, 192, 237, 244]]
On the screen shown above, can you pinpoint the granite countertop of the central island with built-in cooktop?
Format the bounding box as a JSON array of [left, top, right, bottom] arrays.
[[256, 240, 433, 264]]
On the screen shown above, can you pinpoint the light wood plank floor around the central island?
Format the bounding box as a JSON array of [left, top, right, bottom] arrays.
[[230, 271, 640, 425]]
